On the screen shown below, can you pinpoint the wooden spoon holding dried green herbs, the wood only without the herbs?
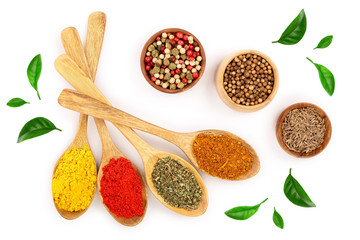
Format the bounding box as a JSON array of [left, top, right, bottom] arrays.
[[55, 55, 208, 217]]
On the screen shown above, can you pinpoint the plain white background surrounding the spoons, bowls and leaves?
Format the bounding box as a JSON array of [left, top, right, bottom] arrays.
[[0, 0, 360, 239]]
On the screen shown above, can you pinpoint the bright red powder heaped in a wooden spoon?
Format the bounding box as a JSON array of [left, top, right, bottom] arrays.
[[100, 158, 144, 219]]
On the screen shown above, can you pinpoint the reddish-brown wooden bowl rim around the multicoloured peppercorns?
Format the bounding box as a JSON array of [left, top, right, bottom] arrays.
[[140, 28, 206, 93]]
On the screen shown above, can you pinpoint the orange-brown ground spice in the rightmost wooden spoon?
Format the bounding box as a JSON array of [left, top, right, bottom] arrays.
[[193, 133, 254, 180]]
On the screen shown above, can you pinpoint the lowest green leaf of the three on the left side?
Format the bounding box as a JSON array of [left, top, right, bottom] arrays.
[[17, 117, 61, 143]]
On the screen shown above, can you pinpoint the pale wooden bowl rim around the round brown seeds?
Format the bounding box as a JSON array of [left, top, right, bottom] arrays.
[[216, 49, 279, 112]]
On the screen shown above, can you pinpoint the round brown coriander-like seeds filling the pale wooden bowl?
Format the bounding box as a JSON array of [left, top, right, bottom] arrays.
[[224, 54, 274, 106]]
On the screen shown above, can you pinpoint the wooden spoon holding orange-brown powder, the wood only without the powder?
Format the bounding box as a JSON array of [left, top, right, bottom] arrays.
[[58, 89, 260, 180]]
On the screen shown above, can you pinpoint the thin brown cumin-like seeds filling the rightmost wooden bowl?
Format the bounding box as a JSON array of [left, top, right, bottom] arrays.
[[281, 107, 326, 153]]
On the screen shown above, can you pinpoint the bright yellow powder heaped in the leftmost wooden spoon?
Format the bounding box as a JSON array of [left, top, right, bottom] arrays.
[[52, 145, 96, 212]]
